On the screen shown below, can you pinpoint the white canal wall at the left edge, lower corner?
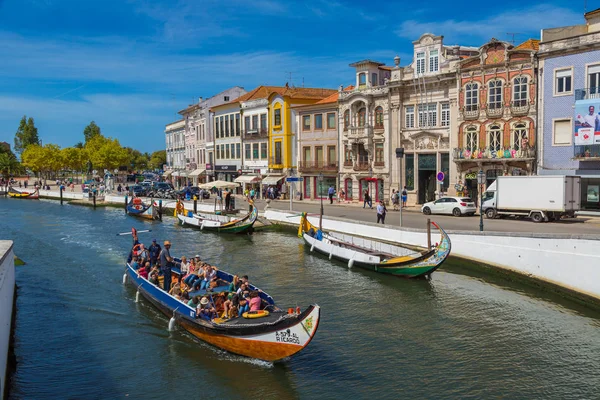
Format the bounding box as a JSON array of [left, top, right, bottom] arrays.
[[0, 240, 15, 399]]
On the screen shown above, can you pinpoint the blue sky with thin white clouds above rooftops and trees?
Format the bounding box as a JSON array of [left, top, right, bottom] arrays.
[[0, 0, 589, 152]]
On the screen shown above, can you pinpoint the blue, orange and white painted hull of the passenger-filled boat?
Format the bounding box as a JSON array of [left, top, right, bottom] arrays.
[[126, 265, 320, 362]]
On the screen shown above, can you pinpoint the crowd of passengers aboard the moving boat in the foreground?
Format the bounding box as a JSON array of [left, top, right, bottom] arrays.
[[130, 237, 262, 321]]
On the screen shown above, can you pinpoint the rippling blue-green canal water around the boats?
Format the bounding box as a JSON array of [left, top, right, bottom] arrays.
[[0, 199, 600, 399]]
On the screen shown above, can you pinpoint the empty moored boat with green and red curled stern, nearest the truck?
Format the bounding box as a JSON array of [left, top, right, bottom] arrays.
[[298, 213, 451, 278]]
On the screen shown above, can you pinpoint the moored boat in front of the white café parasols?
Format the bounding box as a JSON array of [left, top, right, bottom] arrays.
[[175, 201, 258, 233]]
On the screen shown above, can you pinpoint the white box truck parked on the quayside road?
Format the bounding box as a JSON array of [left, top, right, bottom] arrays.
[[481, 175, 581, 222]]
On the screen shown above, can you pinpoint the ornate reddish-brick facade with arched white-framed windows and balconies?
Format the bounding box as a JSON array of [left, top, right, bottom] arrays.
[[452, 39, 538, 196]]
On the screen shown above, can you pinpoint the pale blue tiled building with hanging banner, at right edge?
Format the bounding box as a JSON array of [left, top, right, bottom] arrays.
[[537, 9, 600, 211]]
